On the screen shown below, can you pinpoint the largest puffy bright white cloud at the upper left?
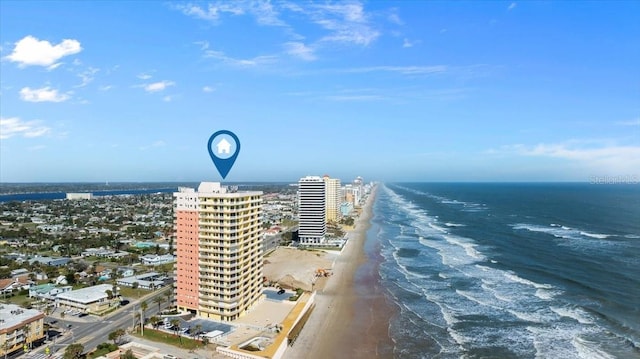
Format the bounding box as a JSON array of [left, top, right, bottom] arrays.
[[6, 35, 82, 69]]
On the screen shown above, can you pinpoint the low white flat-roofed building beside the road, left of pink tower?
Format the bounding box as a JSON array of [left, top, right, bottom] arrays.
[[55, 284, 119, 314]]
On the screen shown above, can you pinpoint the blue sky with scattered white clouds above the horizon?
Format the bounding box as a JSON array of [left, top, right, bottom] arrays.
[[0, 1, 640, 182]]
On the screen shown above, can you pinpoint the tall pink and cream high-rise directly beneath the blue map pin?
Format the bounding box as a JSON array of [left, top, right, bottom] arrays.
[[174, 182, 263, 321]]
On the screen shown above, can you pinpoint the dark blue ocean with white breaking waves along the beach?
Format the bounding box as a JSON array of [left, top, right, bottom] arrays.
[[376, 183, 640, 359]]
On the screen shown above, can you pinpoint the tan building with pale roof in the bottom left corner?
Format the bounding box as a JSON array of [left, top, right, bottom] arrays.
[[0, 304, 44, 357]]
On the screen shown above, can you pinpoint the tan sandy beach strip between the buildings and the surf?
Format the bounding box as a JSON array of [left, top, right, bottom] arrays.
[[285, 189, 394, 359]]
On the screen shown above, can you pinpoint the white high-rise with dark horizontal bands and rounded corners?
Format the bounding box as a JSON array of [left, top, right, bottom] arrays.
[[298, 176, 327, 246]]
